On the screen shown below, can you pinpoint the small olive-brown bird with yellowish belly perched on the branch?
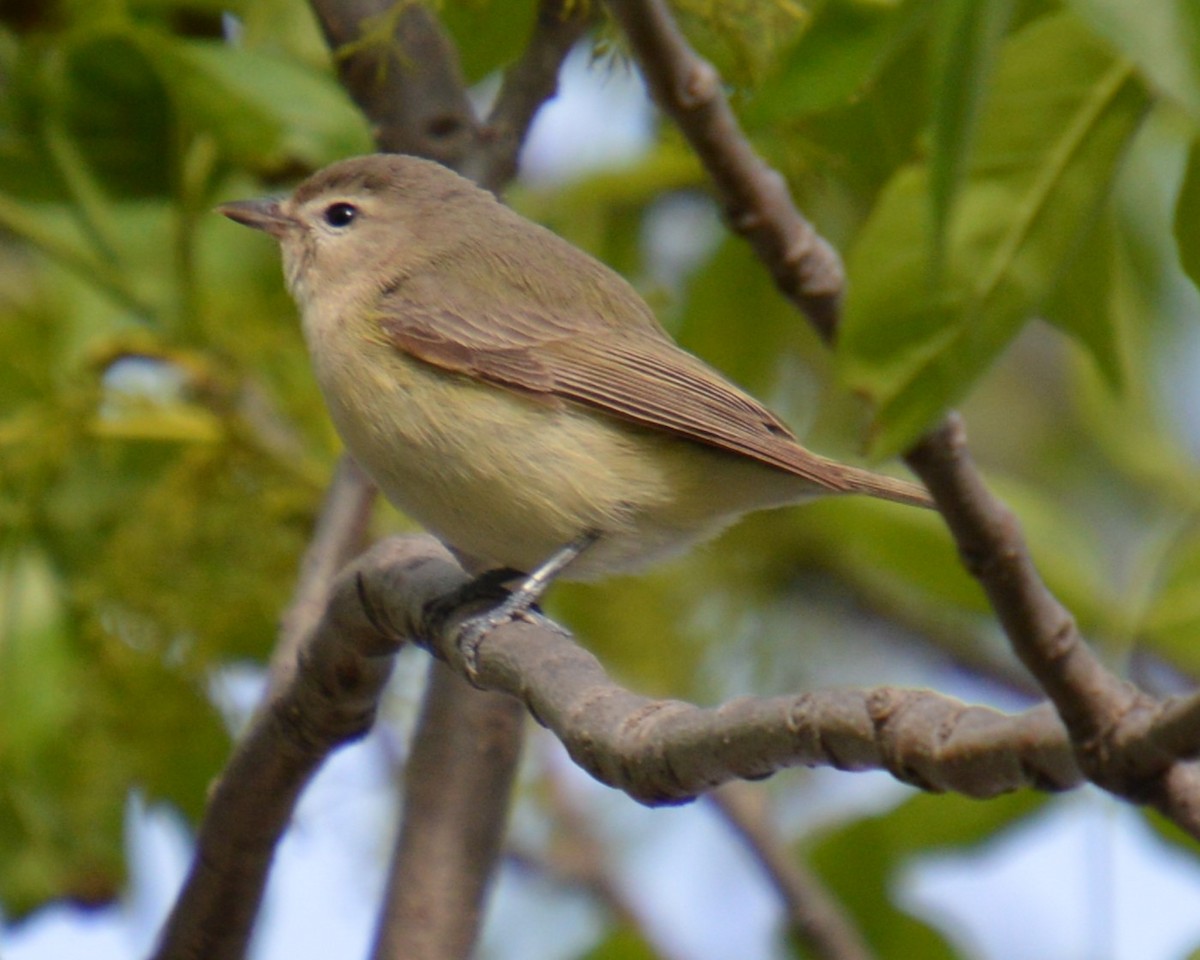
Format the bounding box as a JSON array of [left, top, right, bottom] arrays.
[[220, 155, 930, 588]]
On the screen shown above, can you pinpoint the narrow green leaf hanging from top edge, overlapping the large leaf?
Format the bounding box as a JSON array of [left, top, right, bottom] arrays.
[[929, 0, 1013, 269]]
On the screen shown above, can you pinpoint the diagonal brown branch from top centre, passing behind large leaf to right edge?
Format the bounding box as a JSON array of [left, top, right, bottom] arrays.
[[608, 0, 1200, 835]]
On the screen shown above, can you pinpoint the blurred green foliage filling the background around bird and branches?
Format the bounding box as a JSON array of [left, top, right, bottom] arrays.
[[0, 0, 1200, 956]]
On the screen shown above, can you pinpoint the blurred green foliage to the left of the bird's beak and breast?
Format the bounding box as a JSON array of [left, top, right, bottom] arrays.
[[0, 2, 370, 914]]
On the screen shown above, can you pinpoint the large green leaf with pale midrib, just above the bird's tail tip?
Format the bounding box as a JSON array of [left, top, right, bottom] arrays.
[[839, 14, 1147, 456]]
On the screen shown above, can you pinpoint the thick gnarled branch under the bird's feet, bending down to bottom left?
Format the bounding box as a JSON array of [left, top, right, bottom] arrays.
[[155, 501, 1195, 960]]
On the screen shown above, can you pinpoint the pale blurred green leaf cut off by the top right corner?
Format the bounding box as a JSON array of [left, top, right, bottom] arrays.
[[1070, 0, 1200, 122]]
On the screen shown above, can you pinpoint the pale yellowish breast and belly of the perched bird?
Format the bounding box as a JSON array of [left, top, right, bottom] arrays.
[[307, 333, 803, 578]]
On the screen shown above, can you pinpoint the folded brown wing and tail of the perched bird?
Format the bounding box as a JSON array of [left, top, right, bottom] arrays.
[[380, 266, 929, 505]]
